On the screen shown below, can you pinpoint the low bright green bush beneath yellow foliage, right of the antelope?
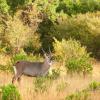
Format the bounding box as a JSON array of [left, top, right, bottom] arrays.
[[66, 57, 92, 76]]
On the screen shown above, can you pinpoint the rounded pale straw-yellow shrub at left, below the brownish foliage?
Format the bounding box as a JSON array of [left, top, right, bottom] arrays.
[[5, 15, 30, 48]]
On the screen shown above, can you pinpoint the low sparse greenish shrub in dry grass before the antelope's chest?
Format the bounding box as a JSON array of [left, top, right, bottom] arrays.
[[34, 69, 60, 92]]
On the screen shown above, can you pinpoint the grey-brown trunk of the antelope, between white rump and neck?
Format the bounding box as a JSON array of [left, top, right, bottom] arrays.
[[16, 61, 43, 76]]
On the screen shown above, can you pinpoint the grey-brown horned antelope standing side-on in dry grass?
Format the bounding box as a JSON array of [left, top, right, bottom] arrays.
[[12, 49, 51, 83]]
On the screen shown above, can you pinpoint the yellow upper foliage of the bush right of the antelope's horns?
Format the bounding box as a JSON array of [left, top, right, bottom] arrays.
[[54, 38, 89, 60]]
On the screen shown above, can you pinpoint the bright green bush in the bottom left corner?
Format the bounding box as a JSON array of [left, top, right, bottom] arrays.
[[2, 85, 21, 100]]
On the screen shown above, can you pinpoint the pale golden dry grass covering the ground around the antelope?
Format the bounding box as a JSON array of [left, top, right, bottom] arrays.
[[0, 62, 100, 100]]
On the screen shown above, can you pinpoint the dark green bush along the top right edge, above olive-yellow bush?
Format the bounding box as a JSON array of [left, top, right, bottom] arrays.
[[56, 0, 100, 15]]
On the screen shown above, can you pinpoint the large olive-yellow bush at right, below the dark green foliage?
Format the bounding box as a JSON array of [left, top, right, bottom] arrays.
[[54, 12, 100, 58]]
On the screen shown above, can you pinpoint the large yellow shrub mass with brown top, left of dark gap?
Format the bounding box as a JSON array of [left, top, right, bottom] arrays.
[[0, 4, 41, 54]]
